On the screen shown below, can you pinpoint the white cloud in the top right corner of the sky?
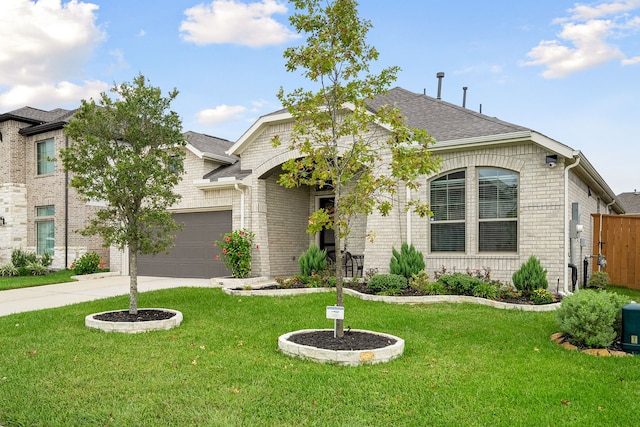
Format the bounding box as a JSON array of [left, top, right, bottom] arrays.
[[522, 0, 640, 78]]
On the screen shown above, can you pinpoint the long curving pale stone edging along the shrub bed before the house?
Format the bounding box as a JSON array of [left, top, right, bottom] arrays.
[[222, 282, 560, 312]]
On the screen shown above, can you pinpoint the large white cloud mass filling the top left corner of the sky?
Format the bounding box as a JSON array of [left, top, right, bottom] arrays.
[[0, 0, 105, 107]]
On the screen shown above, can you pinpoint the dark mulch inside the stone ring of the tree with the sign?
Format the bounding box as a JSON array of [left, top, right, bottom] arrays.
[[289, 330, 396, 350]]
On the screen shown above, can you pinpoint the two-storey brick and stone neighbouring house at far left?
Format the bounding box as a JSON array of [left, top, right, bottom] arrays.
[[0, 107, 109, 268]]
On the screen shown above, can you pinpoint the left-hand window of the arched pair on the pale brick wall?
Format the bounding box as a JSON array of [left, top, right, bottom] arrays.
[[430, 171, 466, 252]]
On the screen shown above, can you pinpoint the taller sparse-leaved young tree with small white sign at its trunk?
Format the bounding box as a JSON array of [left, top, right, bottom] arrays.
[[272, 0, 439, 337]]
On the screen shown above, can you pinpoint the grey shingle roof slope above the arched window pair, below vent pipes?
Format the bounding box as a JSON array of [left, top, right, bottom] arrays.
[[368, 87, 530, 141]]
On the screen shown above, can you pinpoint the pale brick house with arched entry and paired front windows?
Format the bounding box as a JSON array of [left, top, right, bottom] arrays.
[[130, 88, 624, 292]]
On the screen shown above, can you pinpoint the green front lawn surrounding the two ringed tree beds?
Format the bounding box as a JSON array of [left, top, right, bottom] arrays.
[[0, 288, 640, 427]]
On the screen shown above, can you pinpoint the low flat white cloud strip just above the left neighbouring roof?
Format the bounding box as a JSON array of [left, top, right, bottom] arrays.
[[0, 80, 109, 109]]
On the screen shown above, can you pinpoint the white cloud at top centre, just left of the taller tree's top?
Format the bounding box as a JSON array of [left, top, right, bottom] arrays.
[[180, 0, 298, 47]]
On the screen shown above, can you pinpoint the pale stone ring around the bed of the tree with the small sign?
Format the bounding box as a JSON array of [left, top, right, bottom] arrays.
[[278, 329, 404, 366]]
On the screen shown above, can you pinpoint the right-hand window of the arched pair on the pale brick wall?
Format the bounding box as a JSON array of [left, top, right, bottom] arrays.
[[478, 168, 518, 252]]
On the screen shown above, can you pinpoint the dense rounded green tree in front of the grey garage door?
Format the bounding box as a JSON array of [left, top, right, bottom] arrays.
[[60, 75, 185, 314]]
